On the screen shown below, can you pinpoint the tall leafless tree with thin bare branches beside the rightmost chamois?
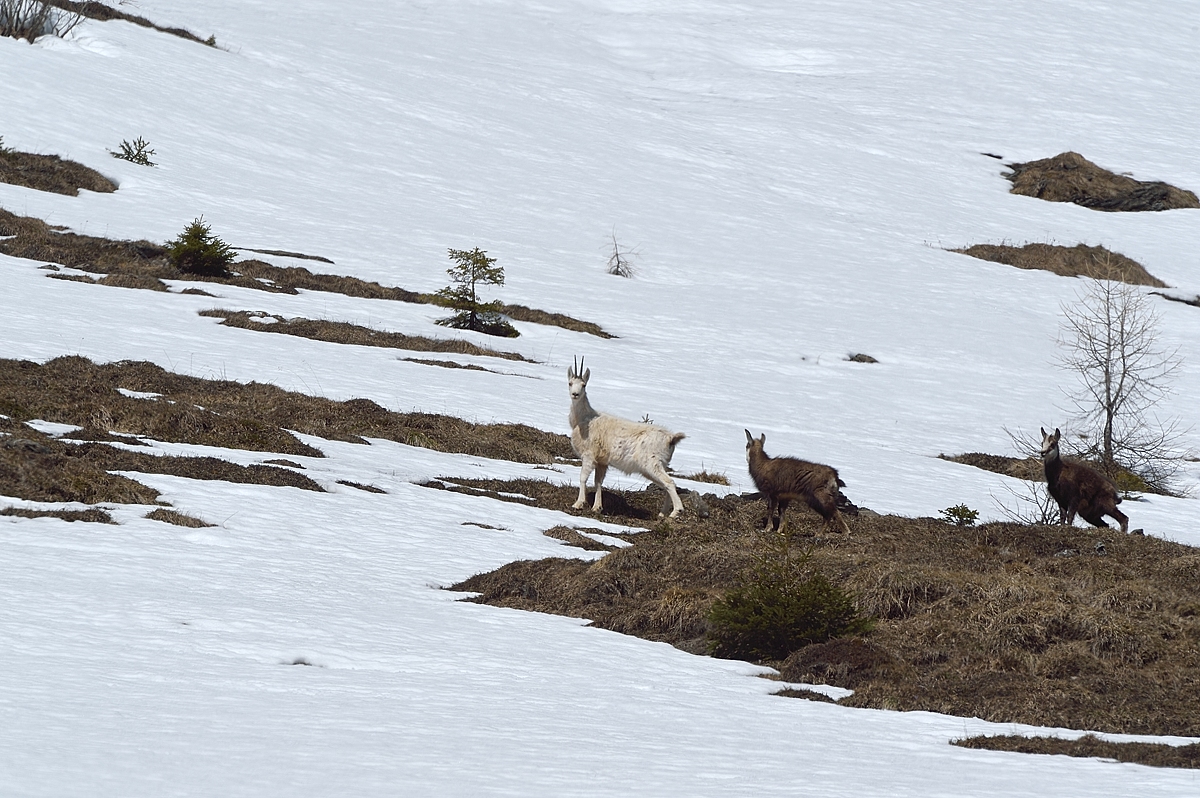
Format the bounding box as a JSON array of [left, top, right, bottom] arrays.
[[1058, 255, 1186, 490]]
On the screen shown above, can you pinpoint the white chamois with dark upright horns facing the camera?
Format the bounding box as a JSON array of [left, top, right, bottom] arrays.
[[566, 361, 684, 518]]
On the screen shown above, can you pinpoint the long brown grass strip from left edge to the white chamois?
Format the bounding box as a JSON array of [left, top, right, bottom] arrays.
[[0, 356, 571, 463]]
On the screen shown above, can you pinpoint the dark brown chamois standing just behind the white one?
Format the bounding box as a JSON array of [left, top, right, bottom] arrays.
[[745, 430, 850, 535]]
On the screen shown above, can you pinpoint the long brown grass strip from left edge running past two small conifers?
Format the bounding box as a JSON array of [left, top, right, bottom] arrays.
[[0, 208, 616, 338]]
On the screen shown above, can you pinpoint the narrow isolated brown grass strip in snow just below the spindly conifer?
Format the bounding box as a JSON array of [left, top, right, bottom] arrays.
[[200, 310, 529, 368]]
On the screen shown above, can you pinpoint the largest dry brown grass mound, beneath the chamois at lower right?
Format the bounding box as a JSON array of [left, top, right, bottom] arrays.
[[452, 482, 1200, 736]]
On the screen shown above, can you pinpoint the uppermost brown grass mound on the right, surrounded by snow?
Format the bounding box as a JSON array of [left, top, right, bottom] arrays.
[[1004, 152, 1200, 211]]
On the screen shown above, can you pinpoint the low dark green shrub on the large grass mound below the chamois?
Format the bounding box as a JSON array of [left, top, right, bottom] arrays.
[[708, 540, 875, 660]]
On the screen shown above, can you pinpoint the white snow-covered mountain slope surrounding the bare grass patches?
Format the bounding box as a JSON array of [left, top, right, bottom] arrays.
[[0, 0, 1200, 796]]
